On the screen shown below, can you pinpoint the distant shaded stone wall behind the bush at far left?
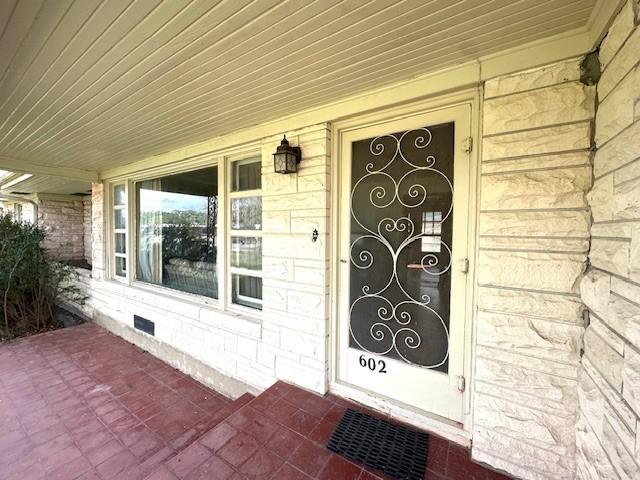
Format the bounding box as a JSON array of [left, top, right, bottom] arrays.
[[37, 198, 84, 260]]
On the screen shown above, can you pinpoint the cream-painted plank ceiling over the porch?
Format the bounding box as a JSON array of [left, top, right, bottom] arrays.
[[0, 0, 596, 171]]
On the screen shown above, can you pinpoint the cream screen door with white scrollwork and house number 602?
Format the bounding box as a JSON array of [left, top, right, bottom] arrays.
[[335, 103, 475, 422]]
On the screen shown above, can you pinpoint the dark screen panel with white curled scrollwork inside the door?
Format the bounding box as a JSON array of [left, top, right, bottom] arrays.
[[349, 122, 455, 373]]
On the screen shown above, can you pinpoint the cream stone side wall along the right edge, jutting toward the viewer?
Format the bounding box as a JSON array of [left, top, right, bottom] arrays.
[[577, 0, 640, 480]]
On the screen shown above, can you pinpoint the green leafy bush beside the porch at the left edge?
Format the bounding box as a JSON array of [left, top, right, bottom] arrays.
[[0, 213, 85, 338]]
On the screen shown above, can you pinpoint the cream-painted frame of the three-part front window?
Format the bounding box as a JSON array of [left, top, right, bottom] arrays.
[[105, 143, 264, 321]]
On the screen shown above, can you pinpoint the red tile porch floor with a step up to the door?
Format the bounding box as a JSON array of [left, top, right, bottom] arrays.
[[0, 324, 507, 480]]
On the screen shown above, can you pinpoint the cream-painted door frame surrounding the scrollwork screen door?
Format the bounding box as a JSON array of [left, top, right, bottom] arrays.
[[329, 89, 480, 445]]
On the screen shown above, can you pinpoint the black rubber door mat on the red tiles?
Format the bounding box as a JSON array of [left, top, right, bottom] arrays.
[[327, 408, 429, 480]]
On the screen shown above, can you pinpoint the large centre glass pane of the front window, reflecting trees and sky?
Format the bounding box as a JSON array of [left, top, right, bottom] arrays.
[[136, 167, 218, 298]]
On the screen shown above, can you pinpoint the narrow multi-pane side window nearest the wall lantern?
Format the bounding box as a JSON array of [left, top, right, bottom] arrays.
[[229, 157, 262, 309]]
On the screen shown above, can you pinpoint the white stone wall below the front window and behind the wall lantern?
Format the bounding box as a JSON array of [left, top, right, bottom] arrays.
[[84, 124, 330, 394]]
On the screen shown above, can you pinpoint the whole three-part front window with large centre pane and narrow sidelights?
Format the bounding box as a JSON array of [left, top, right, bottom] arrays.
[[111, 155, 262, 316]]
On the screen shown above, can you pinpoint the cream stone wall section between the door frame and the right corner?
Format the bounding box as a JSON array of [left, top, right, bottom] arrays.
[[472, 58, 595, 480]]
